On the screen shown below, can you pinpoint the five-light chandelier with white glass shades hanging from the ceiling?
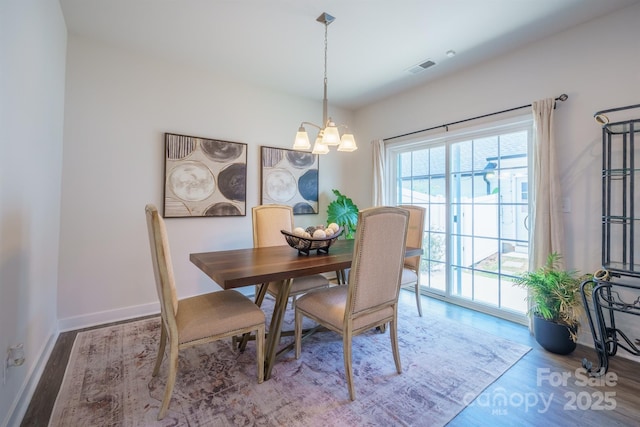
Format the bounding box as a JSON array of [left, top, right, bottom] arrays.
[[293, 12, 358, 154]]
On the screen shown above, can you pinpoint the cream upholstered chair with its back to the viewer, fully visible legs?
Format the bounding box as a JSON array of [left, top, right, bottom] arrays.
[[295, 206, 409, 400]]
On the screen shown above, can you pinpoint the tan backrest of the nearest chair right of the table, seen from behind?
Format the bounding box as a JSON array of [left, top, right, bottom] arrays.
[[345, 206, 409, 320]]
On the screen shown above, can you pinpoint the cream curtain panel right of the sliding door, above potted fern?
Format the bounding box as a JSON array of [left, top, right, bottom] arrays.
[[529, 98, 564, 271]]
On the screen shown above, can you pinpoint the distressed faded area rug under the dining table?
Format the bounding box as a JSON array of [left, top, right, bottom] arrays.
[[49, 300, 530, 427]]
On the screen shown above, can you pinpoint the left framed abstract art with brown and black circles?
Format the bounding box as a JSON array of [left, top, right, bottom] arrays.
[[164, 133, 247, 218]]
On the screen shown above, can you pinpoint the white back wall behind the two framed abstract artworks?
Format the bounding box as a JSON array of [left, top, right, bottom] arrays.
[[58, 36, 360, 330]]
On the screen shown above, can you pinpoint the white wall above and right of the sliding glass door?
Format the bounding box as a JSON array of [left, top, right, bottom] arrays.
[[356, 4, 640, 354]]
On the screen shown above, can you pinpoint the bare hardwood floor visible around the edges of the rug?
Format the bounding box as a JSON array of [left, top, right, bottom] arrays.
[[21, 291, 640, 427]]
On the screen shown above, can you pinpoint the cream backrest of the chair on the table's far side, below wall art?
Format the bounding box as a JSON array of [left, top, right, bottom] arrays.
[[251, 205, 293, 248]]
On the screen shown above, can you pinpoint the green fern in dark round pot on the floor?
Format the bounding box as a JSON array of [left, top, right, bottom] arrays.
[[515, 252, 591, 354]]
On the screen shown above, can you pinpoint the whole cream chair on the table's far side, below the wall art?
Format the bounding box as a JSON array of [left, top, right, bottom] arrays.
[[251, 204, 329, 305]]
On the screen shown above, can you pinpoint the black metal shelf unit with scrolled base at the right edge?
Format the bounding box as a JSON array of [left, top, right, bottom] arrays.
[[581, 105, 640, 376]]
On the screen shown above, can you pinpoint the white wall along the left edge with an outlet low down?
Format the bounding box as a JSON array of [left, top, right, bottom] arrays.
[[0, 0, 66, 426]]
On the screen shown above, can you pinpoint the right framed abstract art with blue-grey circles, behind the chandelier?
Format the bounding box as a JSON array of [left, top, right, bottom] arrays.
[[260, 147, 319, 215]]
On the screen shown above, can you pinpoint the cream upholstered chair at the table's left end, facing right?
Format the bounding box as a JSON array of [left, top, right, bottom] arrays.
[[145, 204, 265, 420]]
